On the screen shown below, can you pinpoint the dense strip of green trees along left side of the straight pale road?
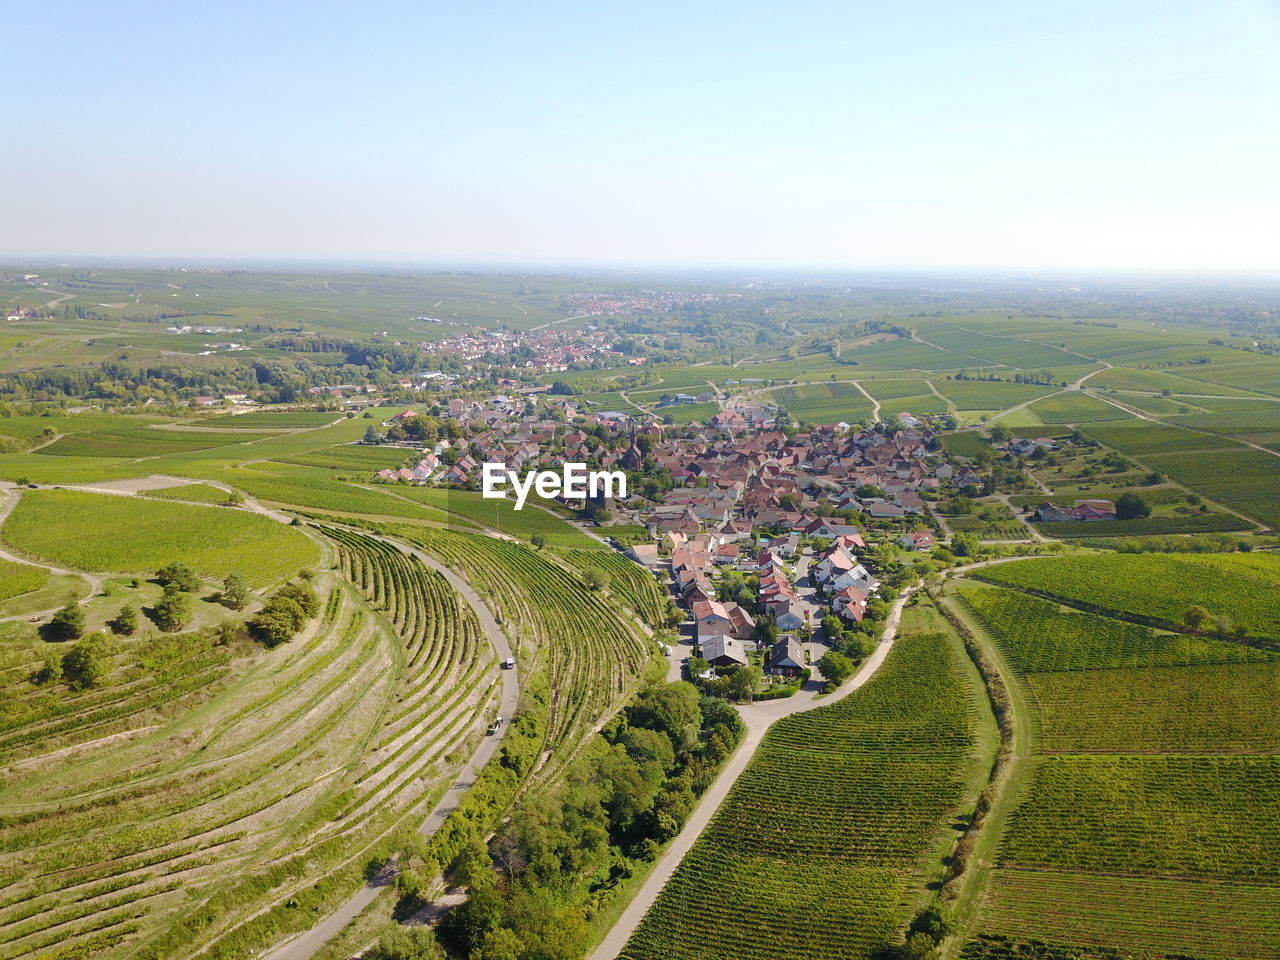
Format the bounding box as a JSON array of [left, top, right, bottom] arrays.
[[437, 682, 744, 960]]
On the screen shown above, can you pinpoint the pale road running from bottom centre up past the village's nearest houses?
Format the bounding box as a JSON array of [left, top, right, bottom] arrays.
[[590, 588, 915, 960]]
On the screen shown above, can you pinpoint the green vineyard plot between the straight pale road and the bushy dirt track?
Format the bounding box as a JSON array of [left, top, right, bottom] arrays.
[[621, 616, 978, 960]]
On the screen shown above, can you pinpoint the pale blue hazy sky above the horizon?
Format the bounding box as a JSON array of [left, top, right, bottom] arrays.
[[0, 0, 1280, 270]]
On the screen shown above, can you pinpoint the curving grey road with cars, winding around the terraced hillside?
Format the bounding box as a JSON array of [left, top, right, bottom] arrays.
[[266, 530, 520, 960]]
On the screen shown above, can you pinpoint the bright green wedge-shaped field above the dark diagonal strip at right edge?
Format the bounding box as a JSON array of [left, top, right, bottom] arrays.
[[967, 552, 1280, 640]]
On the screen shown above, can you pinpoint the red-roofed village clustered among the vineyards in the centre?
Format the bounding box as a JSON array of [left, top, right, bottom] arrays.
[[365, 394, 1003, 691]]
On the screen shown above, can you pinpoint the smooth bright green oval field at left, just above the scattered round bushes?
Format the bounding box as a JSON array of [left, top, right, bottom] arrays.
[[4, 490, 320, 584]]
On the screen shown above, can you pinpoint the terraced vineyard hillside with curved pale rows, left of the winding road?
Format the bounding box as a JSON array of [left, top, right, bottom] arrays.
[[0, 534, 497, 957]]
